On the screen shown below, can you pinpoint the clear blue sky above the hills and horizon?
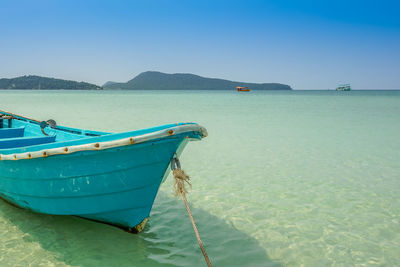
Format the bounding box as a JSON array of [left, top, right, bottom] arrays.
[[0, 0, 400, 89]]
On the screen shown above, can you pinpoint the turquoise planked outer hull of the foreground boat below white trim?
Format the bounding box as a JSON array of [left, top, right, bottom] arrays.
[[0, 136, 188, 229]]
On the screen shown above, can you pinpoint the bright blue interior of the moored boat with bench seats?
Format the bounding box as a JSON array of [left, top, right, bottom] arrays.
[[0, 110, 201, 155]]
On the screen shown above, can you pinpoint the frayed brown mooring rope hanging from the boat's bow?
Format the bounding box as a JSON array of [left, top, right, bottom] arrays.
[[171, 155, 211, 267]]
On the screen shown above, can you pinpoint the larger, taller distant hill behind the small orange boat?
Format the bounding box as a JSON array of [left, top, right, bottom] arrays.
[[103, 71, 292, 90]]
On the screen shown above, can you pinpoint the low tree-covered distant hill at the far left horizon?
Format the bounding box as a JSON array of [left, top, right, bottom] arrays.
[[0, 75, 103, 90]]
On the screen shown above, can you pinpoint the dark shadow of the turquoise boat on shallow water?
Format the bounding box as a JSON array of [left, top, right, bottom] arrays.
[[0, 191, 282, 267]]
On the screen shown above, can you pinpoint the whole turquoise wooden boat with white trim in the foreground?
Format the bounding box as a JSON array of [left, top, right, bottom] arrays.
[[0, 110, 207, 232]]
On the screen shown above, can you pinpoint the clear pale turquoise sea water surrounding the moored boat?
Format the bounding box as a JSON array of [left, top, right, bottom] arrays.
[[0, 91, 400, 266]]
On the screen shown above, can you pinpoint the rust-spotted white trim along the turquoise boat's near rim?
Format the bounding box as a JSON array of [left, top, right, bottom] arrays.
[[0, 124, 208, 160]]
